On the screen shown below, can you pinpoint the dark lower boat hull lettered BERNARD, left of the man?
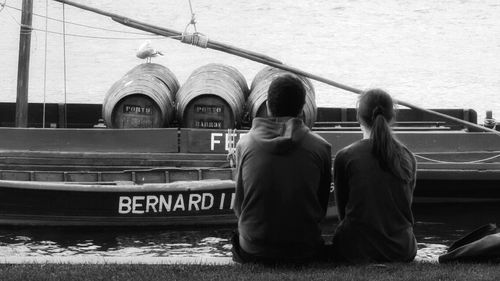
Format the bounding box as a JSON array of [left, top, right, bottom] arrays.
[[0, 180, 236, 226]]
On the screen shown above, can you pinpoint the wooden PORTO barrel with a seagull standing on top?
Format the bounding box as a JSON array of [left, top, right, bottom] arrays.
[[102, 63, 179, 128]]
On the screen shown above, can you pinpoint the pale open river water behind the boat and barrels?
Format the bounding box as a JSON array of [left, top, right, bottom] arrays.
[[0, 0, 500, 121]]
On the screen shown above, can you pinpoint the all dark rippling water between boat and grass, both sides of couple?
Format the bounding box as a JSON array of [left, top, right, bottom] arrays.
[[0, 204, 500, 262]]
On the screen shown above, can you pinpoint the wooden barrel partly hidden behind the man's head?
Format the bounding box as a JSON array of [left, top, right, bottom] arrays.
[[247, 66, 318, 128]]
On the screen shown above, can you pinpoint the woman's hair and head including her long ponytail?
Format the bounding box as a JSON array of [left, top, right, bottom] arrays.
[[358, 89, 415, 183]]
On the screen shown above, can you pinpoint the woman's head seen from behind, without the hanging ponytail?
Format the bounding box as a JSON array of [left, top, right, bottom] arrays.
[[357, 89, 395, 129]]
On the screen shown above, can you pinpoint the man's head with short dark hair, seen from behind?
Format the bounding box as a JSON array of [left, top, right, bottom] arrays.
[[267, 74, 306, 117]]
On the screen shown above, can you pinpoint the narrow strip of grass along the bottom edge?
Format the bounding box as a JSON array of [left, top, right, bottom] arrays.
[[0, 263, 500, 281]]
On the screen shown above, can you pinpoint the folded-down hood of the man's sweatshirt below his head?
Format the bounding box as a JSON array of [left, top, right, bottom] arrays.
[[250, 117, 309, 154]]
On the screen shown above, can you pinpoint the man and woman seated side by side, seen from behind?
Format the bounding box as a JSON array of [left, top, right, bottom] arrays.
[[232, 74, 417, 263]]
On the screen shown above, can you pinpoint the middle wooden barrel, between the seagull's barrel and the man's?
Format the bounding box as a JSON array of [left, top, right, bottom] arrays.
[[177, 63, 248, 129]]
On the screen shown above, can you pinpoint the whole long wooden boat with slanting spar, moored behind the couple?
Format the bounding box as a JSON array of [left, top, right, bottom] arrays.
[[0, 0, 500, 226]]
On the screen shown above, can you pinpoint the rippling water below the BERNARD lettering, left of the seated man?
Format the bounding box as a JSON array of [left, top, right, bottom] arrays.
[[0, 228, 231, 257]]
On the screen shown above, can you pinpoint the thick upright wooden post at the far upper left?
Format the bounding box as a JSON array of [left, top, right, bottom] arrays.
[[16, 0, 33, 127]]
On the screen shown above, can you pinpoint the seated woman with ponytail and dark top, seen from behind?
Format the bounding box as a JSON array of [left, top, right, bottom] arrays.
[[332, 89, 417, 263]]
